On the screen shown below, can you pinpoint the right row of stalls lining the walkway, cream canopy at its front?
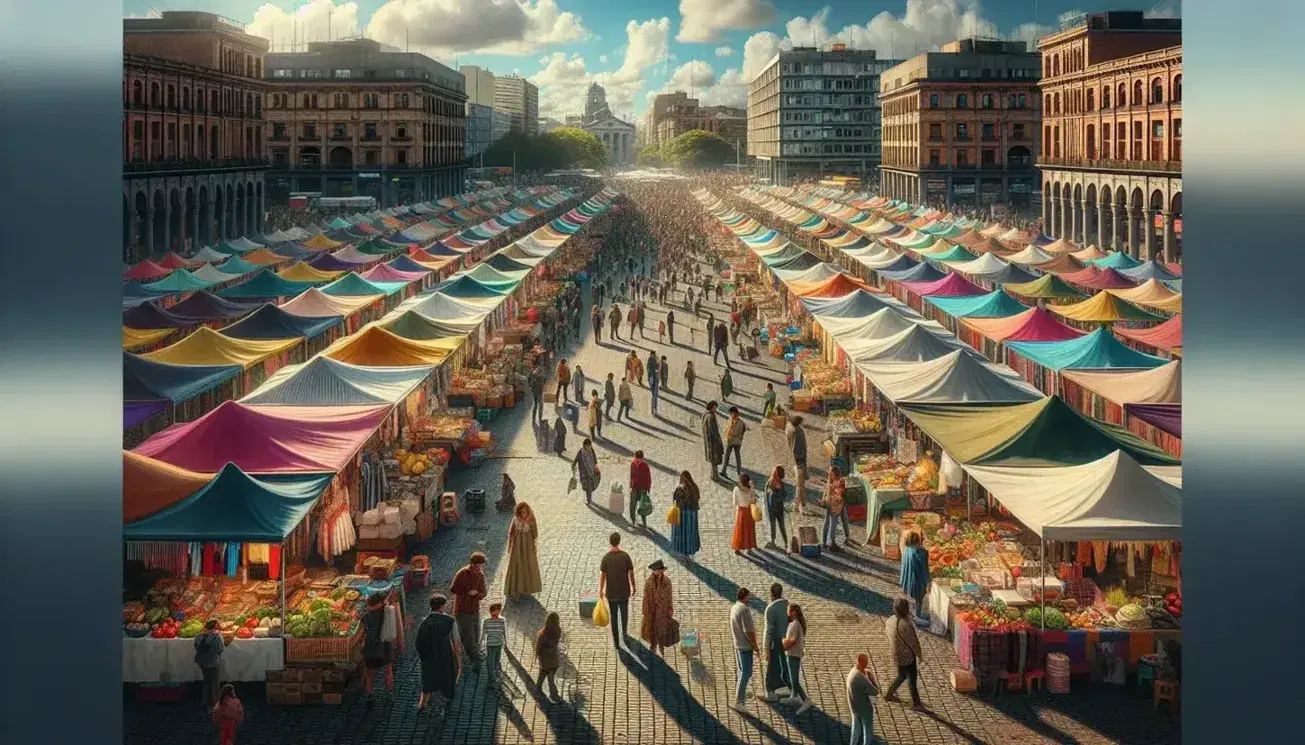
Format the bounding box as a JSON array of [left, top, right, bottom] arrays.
[[697, 189, 1181, 681]]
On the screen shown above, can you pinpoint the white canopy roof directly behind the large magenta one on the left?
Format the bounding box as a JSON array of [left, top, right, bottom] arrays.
[[240, 356, 435, 406]]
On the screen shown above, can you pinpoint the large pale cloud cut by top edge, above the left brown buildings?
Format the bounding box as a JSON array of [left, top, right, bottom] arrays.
[[362, 0, 589, 56]]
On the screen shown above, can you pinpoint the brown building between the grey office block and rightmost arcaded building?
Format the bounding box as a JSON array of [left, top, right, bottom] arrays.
[[880, 39, 1040, 210]]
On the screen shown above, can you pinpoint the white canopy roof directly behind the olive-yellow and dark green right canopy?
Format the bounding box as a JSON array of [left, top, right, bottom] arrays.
[[857, 350, 1043, 403]]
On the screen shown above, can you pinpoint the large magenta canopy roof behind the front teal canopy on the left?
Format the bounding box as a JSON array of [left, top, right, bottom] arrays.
[[134, 401, 393, 474]]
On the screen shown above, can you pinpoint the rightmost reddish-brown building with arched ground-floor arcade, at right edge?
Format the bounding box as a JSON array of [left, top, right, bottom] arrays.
[[1037, 10, 1182, 261]]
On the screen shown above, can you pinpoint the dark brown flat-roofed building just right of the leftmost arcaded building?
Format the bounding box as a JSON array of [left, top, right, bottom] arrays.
[[265, 39, 467, 205]]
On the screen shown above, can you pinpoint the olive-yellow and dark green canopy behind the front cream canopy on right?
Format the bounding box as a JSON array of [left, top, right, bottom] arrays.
[[900, 397, 1178, 468]]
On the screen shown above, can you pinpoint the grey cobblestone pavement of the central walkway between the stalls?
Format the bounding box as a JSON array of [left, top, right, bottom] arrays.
[[124, 264, 1180, 745]]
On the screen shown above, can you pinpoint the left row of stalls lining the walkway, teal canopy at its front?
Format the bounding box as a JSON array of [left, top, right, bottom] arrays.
[[123, 190, 616, 703]]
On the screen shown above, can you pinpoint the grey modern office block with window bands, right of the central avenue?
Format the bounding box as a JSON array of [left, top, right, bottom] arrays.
[[748, 44, 898, 184]]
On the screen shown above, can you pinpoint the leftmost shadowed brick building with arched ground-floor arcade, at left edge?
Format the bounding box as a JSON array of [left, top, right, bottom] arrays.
[[123, 10, 268, 261]]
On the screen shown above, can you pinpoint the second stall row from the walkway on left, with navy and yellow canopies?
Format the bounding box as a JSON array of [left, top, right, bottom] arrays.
[[123, 188, 577, 445]]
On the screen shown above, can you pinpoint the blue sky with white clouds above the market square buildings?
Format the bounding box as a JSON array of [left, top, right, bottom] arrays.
[[124, 0, 1178, 119]]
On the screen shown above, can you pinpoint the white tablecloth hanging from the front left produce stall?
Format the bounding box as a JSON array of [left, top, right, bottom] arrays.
[[123, 637, 286, 682]]
